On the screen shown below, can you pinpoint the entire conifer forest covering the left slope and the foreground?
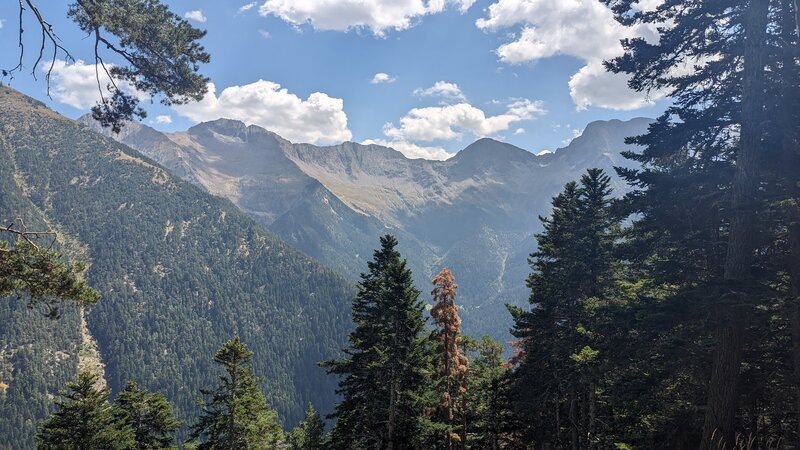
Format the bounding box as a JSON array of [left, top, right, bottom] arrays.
[[0, 0, 800, 450]]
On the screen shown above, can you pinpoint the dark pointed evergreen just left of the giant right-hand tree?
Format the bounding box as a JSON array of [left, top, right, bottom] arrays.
[[512, 169, 616, 449]]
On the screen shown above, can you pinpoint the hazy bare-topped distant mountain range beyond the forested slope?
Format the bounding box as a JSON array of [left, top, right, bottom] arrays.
[[86, 114, 651, 338]]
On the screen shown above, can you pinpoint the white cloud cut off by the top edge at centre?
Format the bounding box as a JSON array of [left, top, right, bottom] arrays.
[[259, 0, 475, 36]]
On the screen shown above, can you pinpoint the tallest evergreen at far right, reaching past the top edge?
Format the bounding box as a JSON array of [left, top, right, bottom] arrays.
[[606, 0, 798, 442]]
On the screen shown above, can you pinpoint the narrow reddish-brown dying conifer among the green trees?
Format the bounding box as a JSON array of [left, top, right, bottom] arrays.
[[431, 268, 469, 450]]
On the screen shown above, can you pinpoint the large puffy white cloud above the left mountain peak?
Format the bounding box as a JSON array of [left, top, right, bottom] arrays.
[[174, 80, 353, 143]]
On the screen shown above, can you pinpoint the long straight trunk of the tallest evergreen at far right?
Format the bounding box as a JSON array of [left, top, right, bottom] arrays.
[[700, 0, 769, 450]]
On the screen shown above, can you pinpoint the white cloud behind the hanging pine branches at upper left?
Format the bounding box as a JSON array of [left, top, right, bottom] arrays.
[[45, 59, 149, 109]]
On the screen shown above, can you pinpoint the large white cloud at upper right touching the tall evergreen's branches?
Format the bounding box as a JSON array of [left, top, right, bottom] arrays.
[[476, 0, 663, 110]]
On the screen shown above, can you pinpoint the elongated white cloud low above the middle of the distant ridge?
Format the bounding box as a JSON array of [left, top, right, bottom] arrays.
[[383, 99, 546, 141]]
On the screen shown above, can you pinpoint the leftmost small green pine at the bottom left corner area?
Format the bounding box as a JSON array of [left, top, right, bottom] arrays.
[[36, 372, 136, 450]]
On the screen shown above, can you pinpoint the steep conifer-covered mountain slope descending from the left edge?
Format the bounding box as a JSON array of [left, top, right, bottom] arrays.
[[0, 87, 352, 448]]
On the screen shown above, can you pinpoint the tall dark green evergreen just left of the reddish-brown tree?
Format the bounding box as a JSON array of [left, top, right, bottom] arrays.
[[323, 235, 430, 450]]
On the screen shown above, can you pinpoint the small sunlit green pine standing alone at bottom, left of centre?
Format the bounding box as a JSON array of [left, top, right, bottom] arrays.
[[191, 337, 283, 450]]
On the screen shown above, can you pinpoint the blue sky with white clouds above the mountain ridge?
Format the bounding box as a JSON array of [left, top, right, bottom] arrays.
[[0, 0, 668, 159]]
